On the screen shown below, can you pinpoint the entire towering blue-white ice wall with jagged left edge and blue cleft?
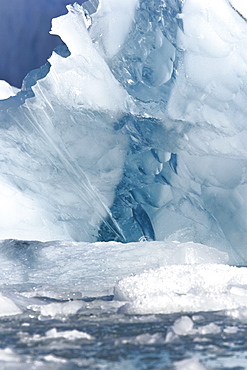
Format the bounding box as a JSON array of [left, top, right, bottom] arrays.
[[0, 0, 247, 259]]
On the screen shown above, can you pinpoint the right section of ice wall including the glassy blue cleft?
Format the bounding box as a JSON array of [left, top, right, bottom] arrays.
[[104, 0, 247, 258]]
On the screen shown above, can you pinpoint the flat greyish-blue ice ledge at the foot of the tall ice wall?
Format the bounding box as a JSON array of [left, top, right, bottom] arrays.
[[0, 240, 229, 300]]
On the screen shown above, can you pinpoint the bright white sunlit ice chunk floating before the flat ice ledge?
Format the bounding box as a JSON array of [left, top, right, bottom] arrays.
[[115, 264, 247, 314]]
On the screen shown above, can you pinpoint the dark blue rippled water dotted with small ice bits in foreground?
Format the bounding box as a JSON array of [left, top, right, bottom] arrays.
[[0, 296, 247, 370]]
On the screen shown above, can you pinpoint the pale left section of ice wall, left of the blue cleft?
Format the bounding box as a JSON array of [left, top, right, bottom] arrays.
[[1, 5, 131, 240]]
